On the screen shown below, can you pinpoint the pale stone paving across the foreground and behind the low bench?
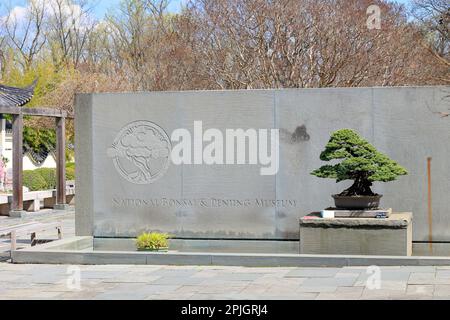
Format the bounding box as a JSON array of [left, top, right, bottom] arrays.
[[0, 211, 450, 300]]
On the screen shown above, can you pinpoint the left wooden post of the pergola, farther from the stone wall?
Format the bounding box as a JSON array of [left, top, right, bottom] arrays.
[[10, 113, 23, 217]]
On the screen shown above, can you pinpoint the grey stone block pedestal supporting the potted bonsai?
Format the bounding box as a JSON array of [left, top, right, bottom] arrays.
[[300, 213, 412, 256]]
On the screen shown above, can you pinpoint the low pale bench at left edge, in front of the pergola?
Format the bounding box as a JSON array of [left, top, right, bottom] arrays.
[[0, 222, 62, 251]]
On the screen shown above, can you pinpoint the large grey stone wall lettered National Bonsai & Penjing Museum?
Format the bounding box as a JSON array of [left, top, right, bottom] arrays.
[[76, 87, 450, 241]]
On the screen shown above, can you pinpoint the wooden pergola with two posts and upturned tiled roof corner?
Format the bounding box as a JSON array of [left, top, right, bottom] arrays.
[[0, 81, 73, 216]]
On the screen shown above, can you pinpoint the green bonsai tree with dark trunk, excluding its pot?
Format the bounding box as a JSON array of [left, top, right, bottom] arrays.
[[311, 129, 408, 196]]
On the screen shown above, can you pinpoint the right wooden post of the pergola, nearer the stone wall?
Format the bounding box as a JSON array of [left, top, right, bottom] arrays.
[[55, 117, 67, 210]]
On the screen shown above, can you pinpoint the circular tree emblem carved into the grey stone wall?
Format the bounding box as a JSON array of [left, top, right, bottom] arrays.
[[108, 120, 172, 184]]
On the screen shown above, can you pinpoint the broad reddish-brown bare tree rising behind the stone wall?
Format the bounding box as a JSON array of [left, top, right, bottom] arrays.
[[180, 0, 432, 89]]
